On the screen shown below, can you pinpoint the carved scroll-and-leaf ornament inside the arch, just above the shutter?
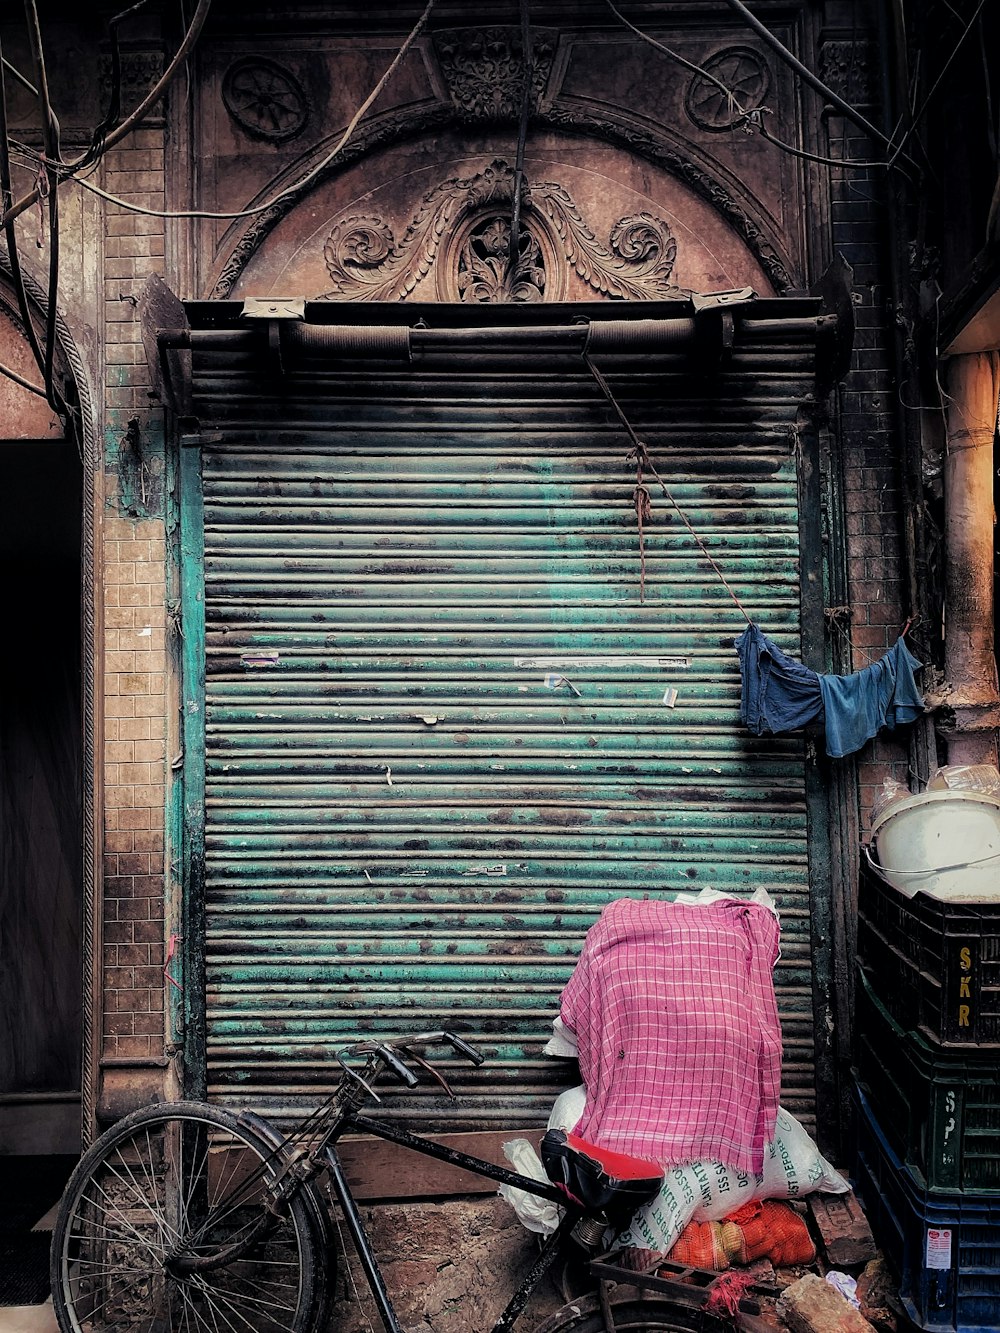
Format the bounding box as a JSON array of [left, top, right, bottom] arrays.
[[321, 159, 689, 304]]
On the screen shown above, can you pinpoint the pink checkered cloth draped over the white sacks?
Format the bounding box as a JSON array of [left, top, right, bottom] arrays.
[[561, 898, 781, 1172]]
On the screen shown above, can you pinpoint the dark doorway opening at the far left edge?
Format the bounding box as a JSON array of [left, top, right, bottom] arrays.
[[0, 440, 83, 1157]]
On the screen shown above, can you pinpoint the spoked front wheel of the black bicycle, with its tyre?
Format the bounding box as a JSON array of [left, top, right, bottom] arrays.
[[52, 1101, 323, 1333]]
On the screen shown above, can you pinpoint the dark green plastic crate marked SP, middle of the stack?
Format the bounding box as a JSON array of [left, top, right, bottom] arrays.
[[855, 970, 1000, 1194]]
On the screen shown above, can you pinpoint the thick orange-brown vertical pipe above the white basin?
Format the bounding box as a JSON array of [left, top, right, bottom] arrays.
[[944, 352, 1000, 764]]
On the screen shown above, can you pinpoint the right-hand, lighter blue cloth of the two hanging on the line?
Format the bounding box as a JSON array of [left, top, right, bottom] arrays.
[[820, 639, 924, 758]]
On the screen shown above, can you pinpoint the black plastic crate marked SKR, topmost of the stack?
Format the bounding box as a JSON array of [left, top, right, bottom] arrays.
[[857, 866, 1000, 1053]]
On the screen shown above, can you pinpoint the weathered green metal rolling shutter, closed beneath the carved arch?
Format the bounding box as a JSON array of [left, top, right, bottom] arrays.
[[187, 306, 813, 1128]]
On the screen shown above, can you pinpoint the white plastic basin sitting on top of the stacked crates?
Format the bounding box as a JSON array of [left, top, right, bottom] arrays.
[[869, 790, 1000, 902]]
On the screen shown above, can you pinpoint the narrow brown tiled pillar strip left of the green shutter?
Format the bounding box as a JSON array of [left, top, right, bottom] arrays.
[[101, 129, 167, 1082]]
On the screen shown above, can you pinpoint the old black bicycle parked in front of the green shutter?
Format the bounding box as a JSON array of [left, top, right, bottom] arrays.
[[52, 1032, 773, 1333]]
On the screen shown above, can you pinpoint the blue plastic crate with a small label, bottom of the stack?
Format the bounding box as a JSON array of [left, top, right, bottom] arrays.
[[855, 1092, 1000, 1333]]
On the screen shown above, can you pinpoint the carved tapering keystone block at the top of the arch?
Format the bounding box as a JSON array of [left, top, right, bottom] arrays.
[[433, 28, 556, 121]]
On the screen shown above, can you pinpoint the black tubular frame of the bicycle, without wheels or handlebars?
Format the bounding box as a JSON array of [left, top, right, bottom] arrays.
[[320, 1109, 587, 1333]]
